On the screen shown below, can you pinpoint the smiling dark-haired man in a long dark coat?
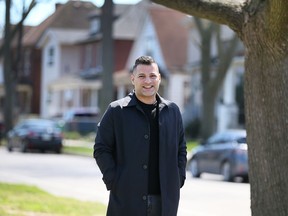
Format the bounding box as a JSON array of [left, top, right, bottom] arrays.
[[94, 56, 187, 216]]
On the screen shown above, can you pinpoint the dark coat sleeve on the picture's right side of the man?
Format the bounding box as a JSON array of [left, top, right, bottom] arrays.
[[178, 108, 187, 187]]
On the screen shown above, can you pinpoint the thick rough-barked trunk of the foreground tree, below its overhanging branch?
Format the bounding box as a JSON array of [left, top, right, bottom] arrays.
[[244, 12, 288, 216]]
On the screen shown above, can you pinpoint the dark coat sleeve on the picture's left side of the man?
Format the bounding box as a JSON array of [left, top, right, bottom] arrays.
[[93, 106, 116, 190]]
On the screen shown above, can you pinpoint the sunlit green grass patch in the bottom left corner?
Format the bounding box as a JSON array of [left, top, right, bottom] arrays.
[[0, 183, 106, 216]]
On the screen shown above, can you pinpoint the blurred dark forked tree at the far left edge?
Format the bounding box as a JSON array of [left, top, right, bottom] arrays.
[[0, 0, 36, 132]]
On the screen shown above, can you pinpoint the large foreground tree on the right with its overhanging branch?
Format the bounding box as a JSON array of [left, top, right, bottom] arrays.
[[154, 0, 288, 216]]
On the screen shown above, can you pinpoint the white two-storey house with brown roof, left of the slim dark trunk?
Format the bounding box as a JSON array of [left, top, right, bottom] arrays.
[[37, 1, 101, 117]]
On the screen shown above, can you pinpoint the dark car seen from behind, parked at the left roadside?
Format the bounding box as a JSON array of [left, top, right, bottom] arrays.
[[7, 119, 63, 153]]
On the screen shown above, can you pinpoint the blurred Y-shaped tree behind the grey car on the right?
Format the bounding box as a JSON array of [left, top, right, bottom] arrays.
[[194, 17, 239, 139]]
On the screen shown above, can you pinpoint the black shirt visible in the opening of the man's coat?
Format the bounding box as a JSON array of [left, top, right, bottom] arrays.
[[138, 100, 161, 195]]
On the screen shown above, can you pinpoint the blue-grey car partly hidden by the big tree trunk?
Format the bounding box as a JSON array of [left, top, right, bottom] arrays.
[[187, 130, 248, 182]]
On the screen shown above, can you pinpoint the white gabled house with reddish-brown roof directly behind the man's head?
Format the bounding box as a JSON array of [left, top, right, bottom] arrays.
[[127, 4, 191, 111]]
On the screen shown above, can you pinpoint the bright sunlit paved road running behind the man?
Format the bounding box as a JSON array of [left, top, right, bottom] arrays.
[[0, 148, 251, 216]]
